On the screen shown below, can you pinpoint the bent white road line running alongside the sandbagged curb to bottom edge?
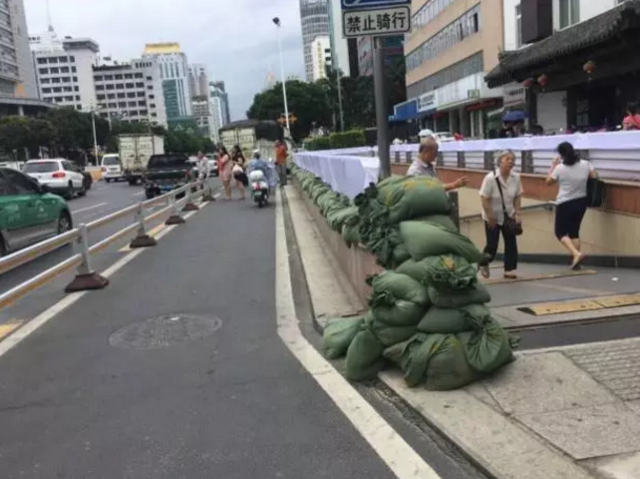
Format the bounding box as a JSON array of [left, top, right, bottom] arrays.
[[275, 192, 440, 479]]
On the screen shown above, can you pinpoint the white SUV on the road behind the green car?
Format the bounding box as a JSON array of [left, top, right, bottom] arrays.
[[22, 158, 87, 200]]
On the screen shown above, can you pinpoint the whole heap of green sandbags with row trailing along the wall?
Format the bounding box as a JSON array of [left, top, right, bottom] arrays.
[[294, 168, 516, 391]]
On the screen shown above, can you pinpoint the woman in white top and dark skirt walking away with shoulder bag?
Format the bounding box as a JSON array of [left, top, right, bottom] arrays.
[[547, 141, 598, 269]]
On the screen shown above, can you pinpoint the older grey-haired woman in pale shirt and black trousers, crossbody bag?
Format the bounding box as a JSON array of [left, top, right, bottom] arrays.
[[480, 150, 522, 279]]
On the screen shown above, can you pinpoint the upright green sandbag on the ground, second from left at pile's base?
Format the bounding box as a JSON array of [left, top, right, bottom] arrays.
[[345, 329, 384, 381]]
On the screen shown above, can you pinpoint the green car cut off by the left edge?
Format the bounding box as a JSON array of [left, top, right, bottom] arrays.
[[0, 168, 73, 255]]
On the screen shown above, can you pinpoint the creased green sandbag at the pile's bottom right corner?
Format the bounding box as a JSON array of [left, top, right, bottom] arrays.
[[459, 319, 514, 374]]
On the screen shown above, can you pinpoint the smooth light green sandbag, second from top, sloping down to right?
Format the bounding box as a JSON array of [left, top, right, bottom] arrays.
[[400, 221, 483, 263]]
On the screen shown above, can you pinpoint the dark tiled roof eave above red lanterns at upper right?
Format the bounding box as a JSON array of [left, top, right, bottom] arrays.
[[485, 0, 640, 88]]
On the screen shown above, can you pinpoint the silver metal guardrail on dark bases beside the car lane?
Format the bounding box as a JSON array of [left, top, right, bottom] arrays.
[[0, 182, 214, 309]]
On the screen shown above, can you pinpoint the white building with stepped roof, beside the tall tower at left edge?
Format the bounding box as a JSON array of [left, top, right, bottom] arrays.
[[30, 34, 100, 111]]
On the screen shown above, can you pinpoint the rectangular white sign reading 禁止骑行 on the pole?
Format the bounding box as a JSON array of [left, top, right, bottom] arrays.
[[342, 5, 411, 38]]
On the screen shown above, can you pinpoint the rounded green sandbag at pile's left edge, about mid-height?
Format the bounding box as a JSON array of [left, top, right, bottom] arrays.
[[368, 271, 429, 306]]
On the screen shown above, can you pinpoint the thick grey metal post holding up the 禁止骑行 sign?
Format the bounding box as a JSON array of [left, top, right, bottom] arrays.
[[373, 37, 391, 179]]
